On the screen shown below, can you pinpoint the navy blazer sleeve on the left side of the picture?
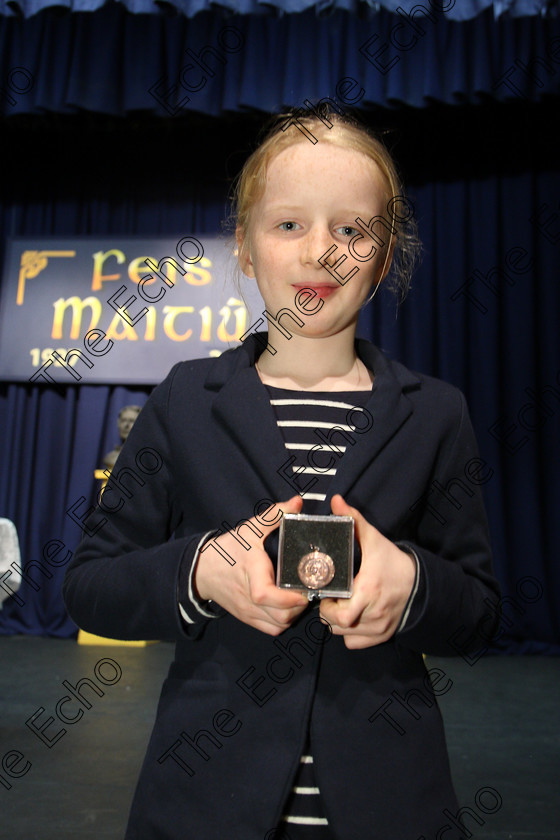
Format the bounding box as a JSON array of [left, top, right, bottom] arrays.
[[63, 365, 214, 640]]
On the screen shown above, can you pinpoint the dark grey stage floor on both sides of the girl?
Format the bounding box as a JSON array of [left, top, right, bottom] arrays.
[[0, 636, 560, 840]]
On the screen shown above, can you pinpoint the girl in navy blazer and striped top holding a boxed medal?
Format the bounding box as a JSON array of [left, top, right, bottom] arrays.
[[65, 114, 498, 840]]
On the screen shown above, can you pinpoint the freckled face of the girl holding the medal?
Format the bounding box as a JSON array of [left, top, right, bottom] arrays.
[[240, 140, 390, 338]]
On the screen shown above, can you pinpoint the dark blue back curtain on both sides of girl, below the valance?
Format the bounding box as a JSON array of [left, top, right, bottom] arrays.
[[0, 103, 560, 653]]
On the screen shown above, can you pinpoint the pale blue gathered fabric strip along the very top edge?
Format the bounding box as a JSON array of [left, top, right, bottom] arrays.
[[0, 0, 557, 20]]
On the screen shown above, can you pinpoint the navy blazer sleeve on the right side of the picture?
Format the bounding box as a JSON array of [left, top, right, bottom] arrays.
[[396, 388, 500, 656]]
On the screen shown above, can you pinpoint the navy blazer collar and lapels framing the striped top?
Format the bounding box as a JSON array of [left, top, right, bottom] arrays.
[[205, 333, 420, 506]]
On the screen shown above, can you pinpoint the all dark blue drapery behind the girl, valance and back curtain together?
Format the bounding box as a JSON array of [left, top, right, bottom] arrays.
[[0, 4, 560, 653]]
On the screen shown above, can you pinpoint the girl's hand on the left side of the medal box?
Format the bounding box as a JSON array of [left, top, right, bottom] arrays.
[[193, 496, 309, 636]]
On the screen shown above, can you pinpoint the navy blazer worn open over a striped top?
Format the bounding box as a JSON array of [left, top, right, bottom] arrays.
[[64, 335, 499, 840]]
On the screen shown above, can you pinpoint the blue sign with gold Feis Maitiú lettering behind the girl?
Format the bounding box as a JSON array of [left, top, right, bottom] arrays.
[[0, 235, 264, 384]]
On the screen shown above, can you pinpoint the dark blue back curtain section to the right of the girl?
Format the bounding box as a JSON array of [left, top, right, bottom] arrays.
[[373, 174, 560, 653]]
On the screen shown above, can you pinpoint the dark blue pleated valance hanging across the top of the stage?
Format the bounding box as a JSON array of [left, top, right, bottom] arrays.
[[0, 3, 560, 117]]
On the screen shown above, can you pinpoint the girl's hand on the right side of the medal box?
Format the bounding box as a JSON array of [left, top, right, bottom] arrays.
[[320, 495, 416, 649]]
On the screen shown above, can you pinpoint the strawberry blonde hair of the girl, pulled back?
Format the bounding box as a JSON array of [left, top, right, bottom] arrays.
[[229, 106, 422, 302]]
